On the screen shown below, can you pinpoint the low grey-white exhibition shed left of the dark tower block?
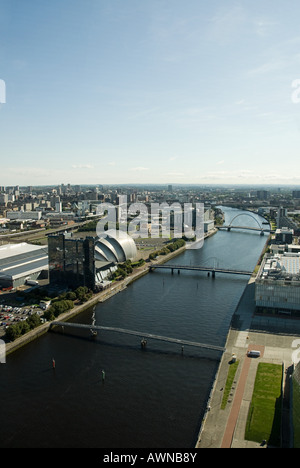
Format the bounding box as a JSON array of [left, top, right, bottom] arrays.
[[0, 242, 49, 289]]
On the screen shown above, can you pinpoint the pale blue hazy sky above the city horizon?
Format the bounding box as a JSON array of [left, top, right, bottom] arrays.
[[0, 0, 300, 186]]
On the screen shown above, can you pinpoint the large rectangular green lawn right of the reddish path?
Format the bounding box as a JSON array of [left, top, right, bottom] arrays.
[[245, 363, 282, 447]]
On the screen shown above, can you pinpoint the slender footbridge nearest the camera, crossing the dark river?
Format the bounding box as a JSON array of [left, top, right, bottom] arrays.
[[50, 321, 225, 352]]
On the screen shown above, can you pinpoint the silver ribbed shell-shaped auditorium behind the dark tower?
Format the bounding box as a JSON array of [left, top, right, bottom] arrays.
[[95, 229, 137, 263]]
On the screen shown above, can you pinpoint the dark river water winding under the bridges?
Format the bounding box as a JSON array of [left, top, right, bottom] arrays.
[[0, 208, 266, 448]]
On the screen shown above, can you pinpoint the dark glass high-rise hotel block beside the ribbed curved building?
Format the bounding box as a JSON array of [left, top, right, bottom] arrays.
[[48, 234, 95, 290]]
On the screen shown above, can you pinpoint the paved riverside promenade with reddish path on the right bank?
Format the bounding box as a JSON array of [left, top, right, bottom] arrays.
[[196, 279, 300, 448]]
